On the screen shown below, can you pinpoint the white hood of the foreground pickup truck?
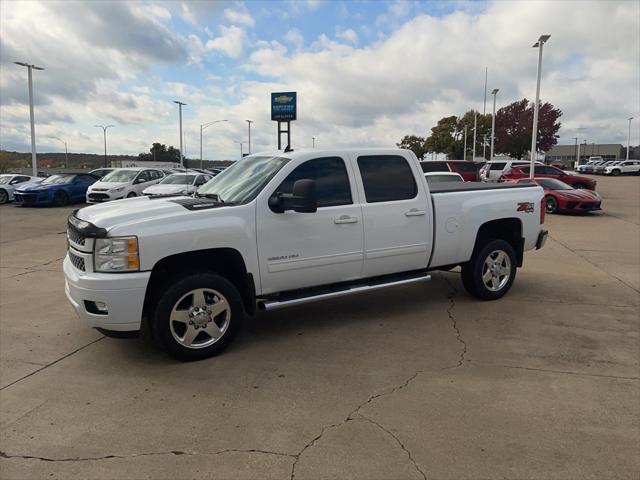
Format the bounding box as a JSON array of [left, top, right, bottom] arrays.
[[76, 196, 223, 230]]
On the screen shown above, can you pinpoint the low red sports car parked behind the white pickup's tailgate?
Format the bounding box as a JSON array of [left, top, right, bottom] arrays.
[[507, 178, 602, 213]]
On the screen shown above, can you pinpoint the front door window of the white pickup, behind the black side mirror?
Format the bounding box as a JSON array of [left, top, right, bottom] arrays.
[[276, 157, 353, 208]]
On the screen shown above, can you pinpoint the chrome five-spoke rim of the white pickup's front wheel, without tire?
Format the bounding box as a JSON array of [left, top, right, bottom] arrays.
[[169, 288, 231, 349]]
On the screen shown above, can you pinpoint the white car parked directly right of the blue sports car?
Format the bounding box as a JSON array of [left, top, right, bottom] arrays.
[[87, 167, 164, 203]]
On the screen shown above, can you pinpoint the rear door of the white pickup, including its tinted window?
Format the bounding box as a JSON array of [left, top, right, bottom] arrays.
[[355, 154, 432, 277]]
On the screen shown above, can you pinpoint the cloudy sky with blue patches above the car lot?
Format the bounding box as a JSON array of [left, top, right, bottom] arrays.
[[0, 0, 640, 159]]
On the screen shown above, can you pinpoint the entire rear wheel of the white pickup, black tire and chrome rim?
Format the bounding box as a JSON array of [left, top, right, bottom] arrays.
[[462, 239, 517, 300]]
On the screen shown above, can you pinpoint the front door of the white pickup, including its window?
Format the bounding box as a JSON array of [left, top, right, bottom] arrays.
[[256, 156, 363, 293]]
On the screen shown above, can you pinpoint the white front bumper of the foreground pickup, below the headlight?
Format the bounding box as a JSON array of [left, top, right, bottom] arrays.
[[62, 255, 151, 332]]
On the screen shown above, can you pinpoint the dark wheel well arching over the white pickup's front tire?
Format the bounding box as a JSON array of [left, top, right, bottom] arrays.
[[142, 248, 256, 317]]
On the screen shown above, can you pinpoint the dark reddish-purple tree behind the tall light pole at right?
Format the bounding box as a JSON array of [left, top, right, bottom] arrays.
[[495, 98, 562, 159]]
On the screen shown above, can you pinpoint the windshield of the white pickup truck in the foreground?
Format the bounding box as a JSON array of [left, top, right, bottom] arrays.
[[198, 157, 289, 204]]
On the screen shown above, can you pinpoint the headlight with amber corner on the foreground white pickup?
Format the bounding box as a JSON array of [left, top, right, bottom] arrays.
[[93, 237, 140, 272]]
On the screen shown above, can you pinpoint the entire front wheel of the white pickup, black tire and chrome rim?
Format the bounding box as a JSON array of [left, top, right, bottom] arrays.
[[153, 273, 244, 361]]
